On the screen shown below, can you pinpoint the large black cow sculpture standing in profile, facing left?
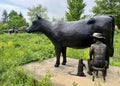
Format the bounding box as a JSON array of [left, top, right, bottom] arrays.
[[27, 15, 115, 67]]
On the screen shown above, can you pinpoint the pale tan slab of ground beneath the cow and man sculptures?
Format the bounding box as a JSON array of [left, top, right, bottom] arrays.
[[23, 58, 120, 86]]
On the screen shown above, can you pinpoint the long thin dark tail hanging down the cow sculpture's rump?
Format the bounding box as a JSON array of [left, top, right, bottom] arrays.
[[109, 15, 115, 57]]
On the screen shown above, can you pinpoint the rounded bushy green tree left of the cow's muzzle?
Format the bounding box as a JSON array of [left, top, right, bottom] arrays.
[[8, 16, 27, 29]]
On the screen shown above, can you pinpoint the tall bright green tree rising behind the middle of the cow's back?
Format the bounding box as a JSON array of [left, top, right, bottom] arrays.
[[66, 0, 86, 21]]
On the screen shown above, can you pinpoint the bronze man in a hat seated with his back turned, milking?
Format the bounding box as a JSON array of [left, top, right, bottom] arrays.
[[88, 33, 107, 75]]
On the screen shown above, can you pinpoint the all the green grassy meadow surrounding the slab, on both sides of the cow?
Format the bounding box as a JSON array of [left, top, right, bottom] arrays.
[[0, 32, 120, 86]]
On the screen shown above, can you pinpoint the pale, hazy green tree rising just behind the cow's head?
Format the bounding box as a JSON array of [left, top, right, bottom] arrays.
[[28, 4, 48, 21]]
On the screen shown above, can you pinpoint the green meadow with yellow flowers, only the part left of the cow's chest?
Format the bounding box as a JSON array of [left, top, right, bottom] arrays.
[[0, 34, 55, 86]]
